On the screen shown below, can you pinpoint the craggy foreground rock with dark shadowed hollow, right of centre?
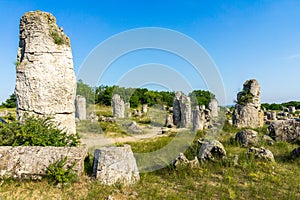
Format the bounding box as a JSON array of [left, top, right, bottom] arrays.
[[198, 139, 226, 162]]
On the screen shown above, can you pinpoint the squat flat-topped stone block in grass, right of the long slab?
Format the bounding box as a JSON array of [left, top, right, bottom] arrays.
[[93, 145, 140, 185]]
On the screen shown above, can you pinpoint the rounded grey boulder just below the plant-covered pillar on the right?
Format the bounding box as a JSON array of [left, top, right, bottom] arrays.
[[235, 129, 258, 147]]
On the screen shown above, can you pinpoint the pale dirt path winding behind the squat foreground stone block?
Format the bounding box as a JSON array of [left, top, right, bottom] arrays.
[[80, 127, 166, 149]]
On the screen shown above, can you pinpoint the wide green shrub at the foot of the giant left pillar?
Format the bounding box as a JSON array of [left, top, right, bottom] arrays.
[[0, 117, 79, 147]]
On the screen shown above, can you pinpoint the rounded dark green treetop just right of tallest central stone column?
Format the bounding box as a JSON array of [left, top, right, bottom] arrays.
[[189, 90, 215, 107]]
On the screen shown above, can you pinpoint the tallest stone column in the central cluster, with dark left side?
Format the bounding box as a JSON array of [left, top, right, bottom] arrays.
[[173, 92, 192, 128]]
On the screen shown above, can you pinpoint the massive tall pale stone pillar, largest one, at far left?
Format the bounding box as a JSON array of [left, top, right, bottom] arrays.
[[15, 11, 76, 134]]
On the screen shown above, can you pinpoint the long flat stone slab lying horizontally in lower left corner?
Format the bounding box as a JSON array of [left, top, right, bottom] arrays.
[[0, 146, 88, 179]]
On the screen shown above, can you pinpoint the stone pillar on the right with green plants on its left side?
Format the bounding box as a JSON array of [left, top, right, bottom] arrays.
[[232, 79, 264, 128]]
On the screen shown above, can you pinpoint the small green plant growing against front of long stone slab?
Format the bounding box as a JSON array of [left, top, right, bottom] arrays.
[[46, 156, 77, 184]]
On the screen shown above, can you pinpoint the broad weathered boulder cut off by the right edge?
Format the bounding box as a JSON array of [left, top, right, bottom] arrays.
[[268, 119, 300, 142]]
